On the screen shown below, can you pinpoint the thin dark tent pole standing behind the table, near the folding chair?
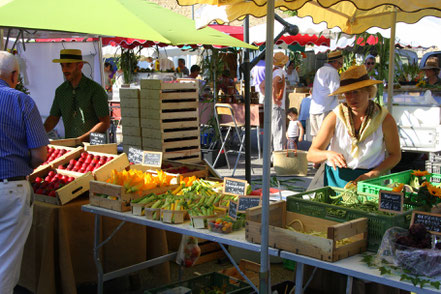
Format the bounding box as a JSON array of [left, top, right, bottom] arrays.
[[243, 15, 251, 184]]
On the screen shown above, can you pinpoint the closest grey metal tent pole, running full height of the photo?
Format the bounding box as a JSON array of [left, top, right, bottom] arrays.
[[259, 0, 274, 294]]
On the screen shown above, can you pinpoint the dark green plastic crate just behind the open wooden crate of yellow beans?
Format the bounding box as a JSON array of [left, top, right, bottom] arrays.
[[286, 187, 415, 251]]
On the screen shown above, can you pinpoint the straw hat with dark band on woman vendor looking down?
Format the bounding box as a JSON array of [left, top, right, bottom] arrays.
[[329, 65, 382, 96]]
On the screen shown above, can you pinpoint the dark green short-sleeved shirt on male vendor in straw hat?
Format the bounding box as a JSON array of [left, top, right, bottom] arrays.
[[50, 75, 109, 138]]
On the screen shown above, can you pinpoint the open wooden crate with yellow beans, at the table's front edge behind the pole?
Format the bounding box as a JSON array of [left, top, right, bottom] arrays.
[[245, 201, 368, 262]]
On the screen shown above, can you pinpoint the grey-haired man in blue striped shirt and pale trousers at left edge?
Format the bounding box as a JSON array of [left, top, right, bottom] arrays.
[[0, 51, 49, 294]]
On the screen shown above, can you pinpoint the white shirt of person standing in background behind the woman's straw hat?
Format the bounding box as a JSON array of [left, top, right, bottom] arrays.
[[309, 63, 340, 114]]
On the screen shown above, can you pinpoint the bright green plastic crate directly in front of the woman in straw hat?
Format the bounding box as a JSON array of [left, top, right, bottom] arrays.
[[357, 170, 441, 197]]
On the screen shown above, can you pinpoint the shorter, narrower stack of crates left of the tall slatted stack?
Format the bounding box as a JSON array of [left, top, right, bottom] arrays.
[[119, 88, 143, 153]]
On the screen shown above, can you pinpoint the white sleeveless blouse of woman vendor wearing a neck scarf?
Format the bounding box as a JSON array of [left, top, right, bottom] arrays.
[[327, 110, 386, 169]]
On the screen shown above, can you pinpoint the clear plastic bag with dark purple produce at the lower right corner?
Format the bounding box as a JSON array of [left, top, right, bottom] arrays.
[[375, 227, 441, 277]]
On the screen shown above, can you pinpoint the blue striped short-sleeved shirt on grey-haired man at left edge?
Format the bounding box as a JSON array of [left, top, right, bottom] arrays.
[[0, 80, 49, 179]]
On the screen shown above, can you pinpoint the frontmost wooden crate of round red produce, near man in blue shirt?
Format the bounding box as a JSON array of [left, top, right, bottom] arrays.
[[29, 166, 93, 205]]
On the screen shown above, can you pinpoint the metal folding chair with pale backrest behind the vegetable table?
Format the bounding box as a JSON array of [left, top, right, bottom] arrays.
[[213, 103, 245, 176]]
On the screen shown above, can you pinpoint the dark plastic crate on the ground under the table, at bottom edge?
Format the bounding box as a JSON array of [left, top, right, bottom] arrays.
[[144, 272, 252, 294]]
